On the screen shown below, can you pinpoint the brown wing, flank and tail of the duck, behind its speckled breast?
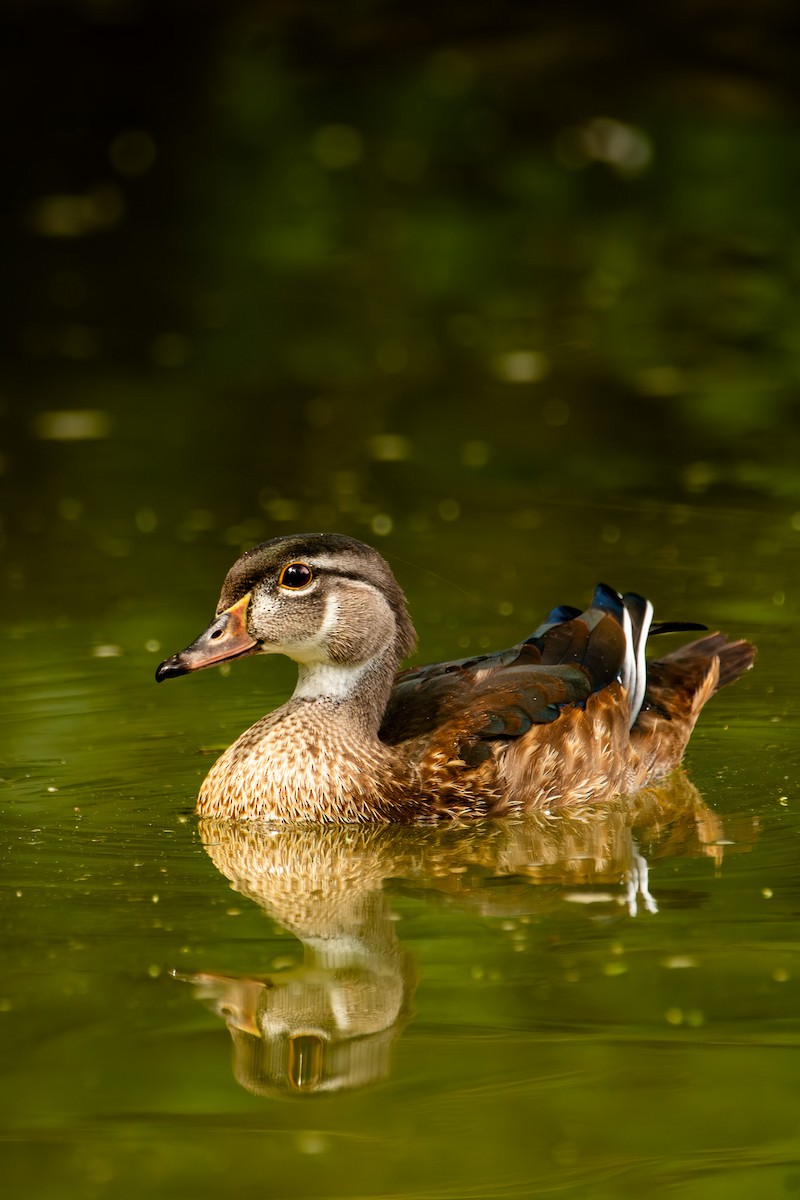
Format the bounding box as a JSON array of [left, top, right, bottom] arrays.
[[380, 584, 754, 814]]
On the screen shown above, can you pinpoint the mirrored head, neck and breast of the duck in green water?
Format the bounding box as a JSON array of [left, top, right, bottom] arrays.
[[184, 820, 415, 1096]]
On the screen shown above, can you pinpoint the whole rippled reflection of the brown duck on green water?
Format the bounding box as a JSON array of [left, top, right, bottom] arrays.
[[179, 772, 753, 1097]]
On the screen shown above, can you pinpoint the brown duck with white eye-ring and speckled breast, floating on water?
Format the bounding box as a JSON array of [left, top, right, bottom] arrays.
[[156, 534, 754, 822]]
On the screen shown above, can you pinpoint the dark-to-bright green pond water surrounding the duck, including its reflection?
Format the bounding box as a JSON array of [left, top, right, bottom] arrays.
[[0, 4, 800, 1200]]
